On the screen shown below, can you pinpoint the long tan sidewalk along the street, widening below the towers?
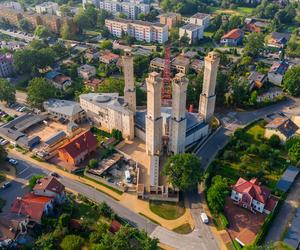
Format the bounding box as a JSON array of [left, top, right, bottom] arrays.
[[9, 149, 194, 230]]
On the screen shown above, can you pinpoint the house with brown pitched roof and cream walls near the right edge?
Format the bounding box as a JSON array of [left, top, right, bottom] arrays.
[[265, 117, 299, 142]]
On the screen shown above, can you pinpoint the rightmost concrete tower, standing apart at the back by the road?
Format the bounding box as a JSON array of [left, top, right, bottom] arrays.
[[199, 51, 220, 122]]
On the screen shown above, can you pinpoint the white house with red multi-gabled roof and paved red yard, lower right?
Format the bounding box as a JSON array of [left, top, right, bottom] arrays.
[[231, 177, 278, 214]]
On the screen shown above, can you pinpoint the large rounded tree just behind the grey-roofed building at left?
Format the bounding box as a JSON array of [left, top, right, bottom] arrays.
[[27, 77, 56, 108]]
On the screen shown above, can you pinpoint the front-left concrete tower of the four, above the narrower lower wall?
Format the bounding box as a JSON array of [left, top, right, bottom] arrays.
[[146, 72, 163, 155]]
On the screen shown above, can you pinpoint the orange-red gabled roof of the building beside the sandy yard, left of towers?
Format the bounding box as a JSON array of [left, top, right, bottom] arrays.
[[58, 130, 98, 159]]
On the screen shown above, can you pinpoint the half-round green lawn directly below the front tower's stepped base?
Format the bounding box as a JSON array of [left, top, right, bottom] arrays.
[[149, 201, 185, 220]]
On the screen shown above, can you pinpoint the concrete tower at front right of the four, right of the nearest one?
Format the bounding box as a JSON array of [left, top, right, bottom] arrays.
[[169, 73, 188, 154]]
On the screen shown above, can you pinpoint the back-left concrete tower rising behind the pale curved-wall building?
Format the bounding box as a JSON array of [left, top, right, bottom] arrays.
[[122, 50, 136, 114]]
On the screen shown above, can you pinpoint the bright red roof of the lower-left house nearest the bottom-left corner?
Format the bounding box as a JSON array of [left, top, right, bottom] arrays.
[[11, 193, 53, 221]]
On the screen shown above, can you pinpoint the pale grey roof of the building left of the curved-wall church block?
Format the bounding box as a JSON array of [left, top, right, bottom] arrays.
[[43, 99, 83, 116]]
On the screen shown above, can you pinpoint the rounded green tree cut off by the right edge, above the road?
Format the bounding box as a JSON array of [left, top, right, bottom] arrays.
[[283, 65, 300, 96]]
